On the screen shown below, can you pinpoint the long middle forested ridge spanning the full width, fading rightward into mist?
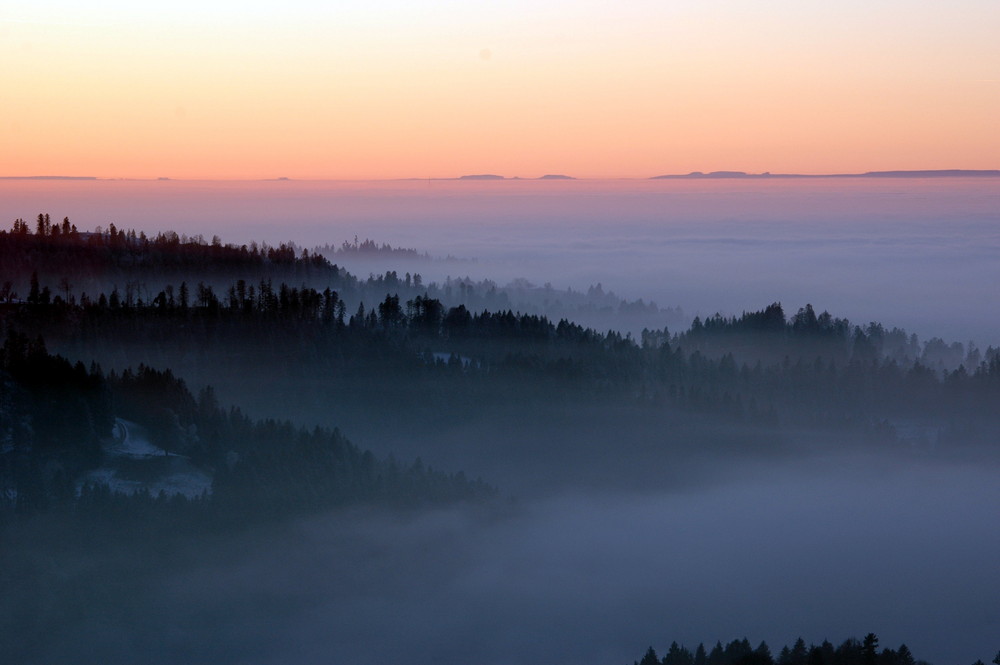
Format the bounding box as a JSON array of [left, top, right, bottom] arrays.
[[7, 282, 1000, 448]]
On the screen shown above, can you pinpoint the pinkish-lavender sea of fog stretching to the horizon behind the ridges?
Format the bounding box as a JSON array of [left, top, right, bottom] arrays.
[[0, 178, 1000, 348]]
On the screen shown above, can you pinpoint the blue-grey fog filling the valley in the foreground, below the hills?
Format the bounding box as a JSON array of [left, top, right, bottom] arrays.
[[23, 454, 1000, 665]]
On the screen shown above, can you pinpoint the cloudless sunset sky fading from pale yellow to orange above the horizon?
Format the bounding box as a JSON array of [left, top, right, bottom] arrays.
[[0, 0, 1000, 179]]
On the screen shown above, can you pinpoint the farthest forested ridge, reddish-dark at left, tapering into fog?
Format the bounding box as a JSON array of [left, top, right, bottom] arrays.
[[0, 214, 687, 330]]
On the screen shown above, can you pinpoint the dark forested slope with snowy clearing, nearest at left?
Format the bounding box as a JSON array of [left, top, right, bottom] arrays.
[[0, 332, 493, 524]]
